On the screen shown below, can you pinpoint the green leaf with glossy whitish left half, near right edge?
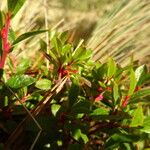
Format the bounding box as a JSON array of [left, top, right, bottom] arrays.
[[135, 65, 148, 85]]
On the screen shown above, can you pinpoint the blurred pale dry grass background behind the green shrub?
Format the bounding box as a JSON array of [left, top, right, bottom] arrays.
[[0, 0, 150, 67]]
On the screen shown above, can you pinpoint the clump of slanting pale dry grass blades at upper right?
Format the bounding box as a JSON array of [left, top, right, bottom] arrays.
[[88, 0, 150, 66]]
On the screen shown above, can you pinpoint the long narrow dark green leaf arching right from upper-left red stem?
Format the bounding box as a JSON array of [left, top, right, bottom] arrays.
[[12, 30, 48, 46]]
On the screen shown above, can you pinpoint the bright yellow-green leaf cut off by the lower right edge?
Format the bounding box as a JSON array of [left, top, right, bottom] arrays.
[[141, 116, 150, 134]]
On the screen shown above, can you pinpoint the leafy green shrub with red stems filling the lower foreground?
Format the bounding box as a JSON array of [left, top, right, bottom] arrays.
[[0, 1, 150, 150]]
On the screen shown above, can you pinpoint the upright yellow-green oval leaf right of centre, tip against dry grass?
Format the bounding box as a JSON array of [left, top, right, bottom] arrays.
[[107, 58, 116, 78]]
